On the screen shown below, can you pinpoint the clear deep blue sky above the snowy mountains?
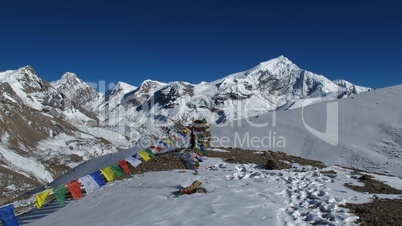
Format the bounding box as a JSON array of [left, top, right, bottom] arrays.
[[0, 0, 402, 88]]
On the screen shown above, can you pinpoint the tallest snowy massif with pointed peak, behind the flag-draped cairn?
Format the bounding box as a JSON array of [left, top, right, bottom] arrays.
[[93, 55, 367, 131]]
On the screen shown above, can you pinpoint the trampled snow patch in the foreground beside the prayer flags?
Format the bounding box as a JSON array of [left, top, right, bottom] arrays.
[[19, 158, 402, 226]]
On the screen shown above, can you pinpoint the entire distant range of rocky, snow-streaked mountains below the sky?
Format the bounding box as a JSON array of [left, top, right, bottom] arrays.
[[0, 56, 370, 203]]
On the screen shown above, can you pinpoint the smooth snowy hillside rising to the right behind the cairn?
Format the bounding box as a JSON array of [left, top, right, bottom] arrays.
[[211, 85, 402, 176]]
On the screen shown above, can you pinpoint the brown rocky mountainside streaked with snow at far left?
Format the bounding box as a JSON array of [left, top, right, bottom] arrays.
[[0, 66, 117, 201]]
